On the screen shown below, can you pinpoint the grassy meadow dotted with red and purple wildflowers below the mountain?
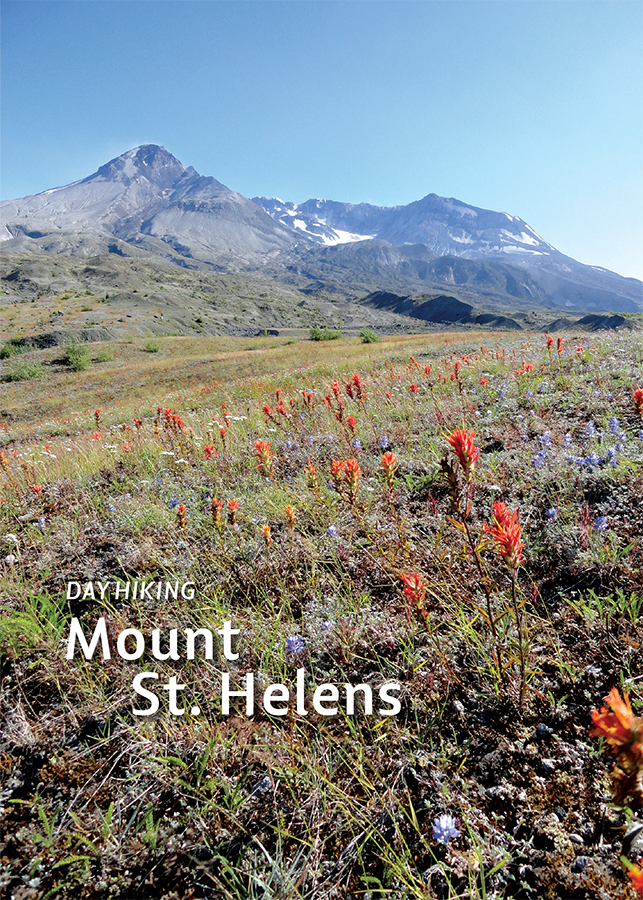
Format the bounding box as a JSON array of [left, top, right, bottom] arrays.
[[0, 332, 643, 900]]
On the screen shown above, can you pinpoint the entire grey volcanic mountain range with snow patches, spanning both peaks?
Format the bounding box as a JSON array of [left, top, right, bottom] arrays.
[[0, 144, 643, 311]]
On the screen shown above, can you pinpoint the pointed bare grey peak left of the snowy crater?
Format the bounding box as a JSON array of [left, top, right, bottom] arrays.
[[0, 144, 296, 263]]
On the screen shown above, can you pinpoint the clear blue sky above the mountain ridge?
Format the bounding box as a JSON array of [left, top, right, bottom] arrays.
[[0, 0, 643, 278]]
